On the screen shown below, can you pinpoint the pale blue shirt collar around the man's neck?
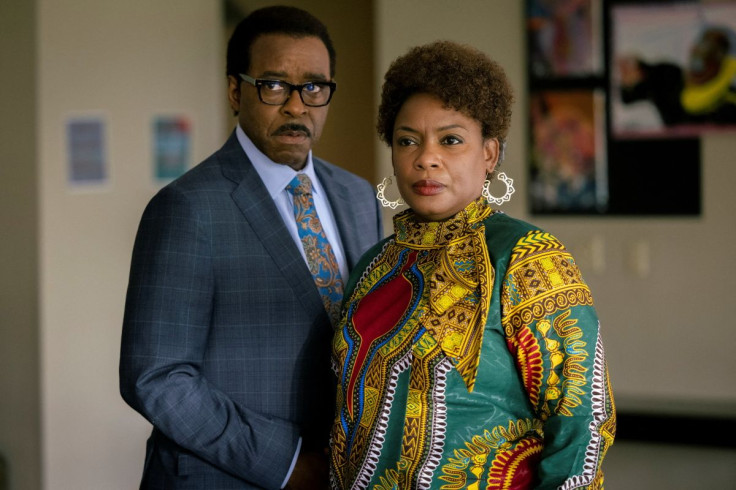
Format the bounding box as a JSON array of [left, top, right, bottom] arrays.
[[235, 125, 322, 199]]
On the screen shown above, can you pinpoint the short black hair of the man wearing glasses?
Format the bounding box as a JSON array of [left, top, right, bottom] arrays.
[[226, 5, 336, 78]]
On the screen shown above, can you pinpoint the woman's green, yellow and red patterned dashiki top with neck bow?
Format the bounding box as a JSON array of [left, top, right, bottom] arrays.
[[330, 198, 615, 490]]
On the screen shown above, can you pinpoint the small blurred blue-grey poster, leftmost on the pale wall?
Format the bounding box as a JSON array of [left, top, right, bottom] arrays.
[[66, 117, 108, 186]]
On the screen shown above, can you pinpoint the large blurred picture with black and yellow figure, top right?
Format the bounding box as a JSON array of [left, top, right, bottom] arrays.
[[609, 2, 736, 139]]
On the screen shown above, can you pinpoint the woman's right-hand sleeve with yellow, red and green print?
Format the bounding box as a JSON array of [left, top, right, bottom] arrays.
[[502, 231, 615, 489]]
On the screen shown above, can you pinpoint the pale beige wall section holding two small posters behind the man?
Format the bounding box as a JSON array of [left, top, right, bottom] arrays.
[[37, 0, 225, 490]]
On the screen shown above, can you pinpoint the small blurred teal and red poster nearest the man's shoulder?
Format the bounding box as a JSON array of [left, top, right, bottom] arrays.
[[153, 116, 191, 180]]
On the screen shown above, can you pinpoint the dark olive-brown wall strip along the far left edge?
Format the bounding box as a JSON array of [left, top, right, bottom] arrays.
[[0, 0, 41, 489]]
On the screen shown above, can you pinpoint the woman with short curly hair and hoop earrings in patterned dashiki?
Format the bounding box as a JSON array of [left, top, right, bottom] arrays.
[[330, 42, 615, 490]]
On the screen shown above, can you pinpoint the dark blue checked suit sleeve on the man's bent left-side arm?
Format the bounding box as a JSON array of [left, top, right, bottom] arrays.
[[120, 186, 299, 488]]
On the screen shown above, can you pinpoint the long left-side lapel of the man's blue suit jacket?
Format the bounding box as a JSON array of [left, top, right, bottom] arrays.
[[218, 133, 324, 314]]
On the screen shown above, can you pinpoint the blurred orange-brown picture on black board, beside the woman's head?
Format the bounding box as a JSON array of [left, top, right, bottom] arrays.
[[530, 90, 608, 213]]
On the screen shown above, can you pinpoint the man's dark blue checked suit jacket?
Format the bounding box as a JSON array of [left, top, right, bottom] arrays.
[[120, 133, 382, 489]]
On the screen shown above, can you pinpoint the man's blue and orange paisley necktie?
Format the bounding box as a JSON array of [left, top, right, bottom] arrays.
[[286, 174, 343, 326]]
